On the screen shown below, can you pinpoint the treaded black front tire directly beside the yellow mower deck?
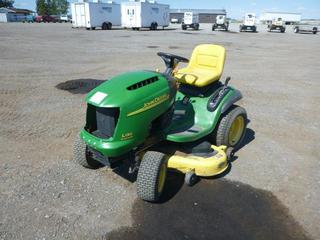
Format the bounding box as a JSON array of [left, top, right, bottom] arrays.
[[137, 151, 167, 202]]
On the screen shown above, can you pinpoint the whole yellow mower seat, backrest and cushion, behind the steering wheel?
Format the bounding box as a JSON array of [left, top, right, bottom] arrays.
[[174, 44, 226, 87]]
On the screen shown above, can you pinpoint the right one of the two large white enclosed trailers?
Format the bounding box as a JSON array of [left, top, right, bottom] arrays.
[[121, 0, 169, 30]]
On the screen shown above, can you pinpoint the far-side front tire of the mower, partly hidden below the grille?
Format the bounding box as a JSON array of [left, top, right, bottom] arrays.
[[73, 136, 102, 169]]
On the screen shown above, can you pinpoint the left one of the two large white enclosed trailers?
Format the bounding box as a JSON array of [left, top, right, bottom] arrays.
[[71, 0, 121, 30]]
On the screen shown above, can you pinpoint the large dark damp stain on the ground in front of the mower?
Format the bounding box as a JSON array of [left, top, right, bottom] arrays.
[[107, 179, 311, 240]]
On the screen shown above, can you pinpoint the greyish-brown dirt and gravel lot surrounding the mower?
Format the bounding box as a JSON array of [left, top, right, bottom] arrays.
[[0, 23, 320, 239]]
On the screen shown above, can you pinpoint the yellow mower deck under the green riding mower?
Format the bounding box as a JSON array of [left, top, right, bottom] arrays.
[[167, 145, 228, 177]]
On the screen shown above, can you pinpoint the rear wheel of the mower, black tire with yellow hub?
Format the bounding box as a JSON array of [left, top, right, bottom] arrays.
[[215, 105, 248, 150]]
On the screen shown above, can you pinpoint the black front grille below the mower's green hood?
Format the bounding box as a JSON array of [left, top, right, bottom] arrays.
[[86, 104, 119, 138]]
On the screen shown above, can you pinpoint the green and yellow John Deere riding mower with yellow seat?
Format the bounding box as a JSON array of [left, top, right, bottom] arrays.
[[74, 44, 247, 202]]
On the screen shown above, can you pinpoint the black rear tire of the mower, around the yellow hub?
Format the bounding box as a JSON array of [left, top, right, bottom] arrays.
[[214, 105, 248, 150]]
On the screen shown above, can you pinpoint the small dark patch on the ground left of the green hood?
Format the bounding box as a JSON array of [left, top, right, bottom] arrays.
[[55, 78, 105, 94]]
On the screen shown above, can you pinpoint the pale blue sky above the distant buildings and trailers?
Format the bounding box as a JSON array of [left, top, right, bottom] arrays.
[[14, 0, 320, 19]]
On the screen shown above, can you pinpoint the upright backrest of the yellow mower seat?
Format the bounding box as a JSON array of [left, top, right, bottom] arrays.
[[188, 44, 226, 78]]
